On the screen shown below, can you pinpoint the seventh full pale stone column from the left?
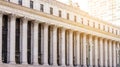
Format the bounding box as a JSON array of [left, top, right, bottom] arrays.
[[69, 30, 73, 66]]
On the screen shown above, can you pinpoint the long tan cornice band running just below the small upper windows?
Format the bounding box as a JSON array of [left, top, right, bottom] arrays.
[[0, 1, 120, 38]]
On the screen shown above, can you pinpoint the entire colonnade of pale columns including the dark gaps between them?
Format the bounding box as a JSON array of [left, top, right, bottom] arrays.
[[0, 13, 120, 67]]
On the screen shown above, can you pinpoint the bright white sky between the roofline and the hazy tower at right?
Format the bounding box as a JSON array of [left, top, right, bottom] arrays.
[[58, 0, 88, 12]]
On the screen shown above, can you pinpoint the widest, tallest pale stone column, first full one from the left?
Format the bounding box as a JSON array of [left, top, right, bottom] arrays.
[[9, 15, 16, 64]]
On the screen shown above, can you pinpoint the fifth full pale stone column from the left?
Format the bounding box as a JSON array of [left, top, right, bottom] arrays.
[[53, 26, 57, 66]]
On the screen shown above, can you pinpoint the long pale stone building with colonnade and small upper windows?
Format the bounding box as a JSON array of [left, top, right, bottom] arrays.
[[0, 0, 120, 67]]
